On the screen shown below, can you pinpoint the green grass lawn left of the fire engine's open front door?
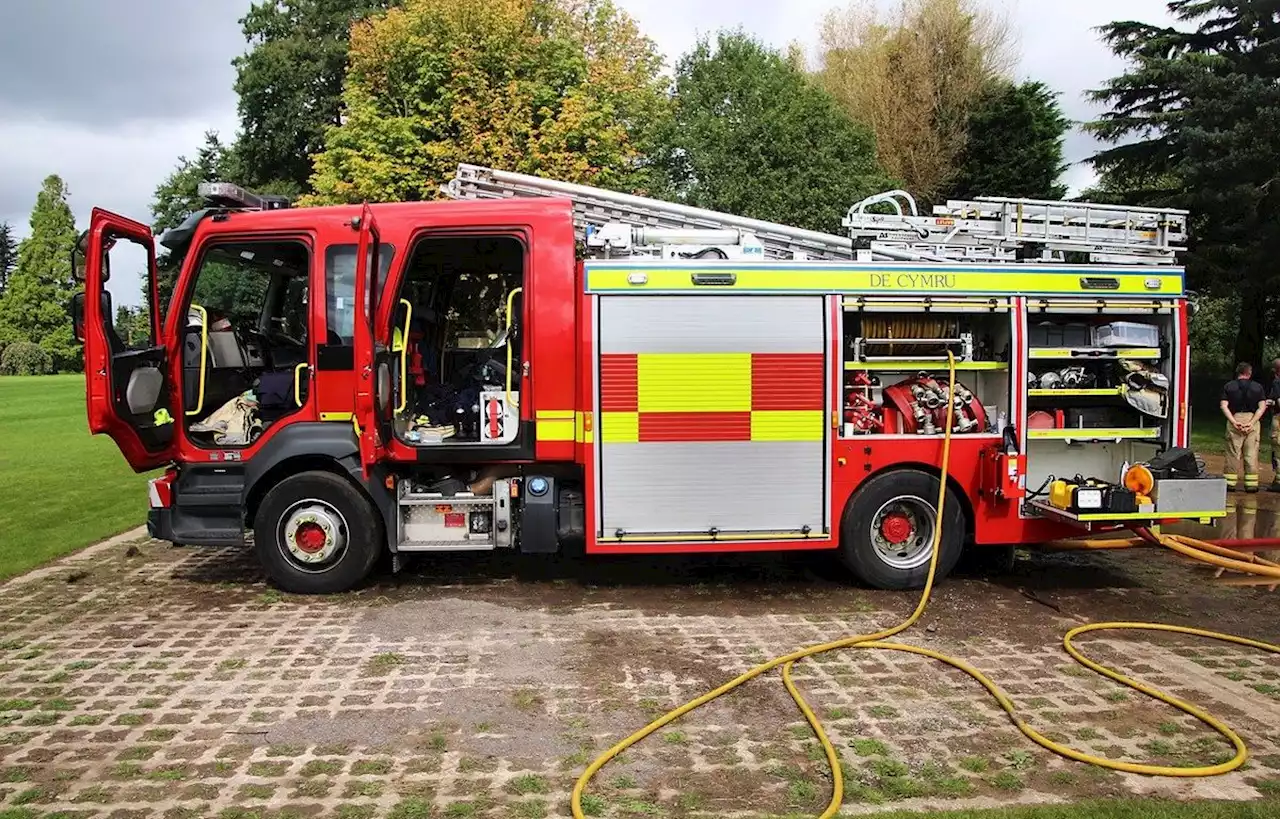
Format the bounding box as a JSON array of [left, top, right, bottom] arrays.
[[0, 375, 148, 578]]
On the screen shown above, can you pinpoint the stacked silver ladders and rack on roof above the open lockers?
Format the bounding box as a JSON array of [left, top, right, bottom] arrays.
[[844, 191, 1189, 265]]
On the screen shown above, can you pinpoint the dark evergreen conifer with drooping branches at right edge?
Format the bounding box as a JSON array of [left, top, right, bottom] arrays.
[[1091, 0, 1280, 365]]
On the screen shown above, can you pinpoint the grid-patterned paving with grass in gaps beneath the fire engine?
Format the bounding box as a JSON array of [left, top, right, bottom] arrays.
[[0, 540, 1280, 819]]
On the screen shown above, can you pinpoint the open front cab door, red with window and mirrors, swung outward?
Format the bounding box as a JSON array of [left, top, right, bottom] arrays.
[[72, 209, 177, 472]]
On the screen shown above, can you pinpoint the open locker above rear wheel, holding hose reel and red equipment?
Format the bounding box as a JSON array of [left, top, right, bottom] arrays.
[[838, 297, 1012, 439]]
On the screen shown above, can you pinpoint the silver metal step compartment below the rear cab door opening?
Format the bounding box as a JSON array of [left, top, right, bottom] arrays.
[[396, 481, 513, 552]]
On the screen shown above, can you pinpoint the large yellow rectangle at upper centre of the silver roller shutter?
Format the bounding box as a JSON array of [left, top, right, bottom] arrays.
[[636, 353, 751, 412]]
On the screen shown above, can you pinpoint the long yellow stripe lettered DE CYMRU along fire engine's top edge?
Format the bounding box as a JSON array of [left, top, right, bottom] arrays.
[[586, 265, 1183, 297]]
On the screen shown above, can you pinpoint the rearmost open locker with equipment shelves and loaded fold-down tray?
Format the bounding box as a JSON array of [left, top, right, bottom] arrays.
[[1023, 299, 1226, 529]]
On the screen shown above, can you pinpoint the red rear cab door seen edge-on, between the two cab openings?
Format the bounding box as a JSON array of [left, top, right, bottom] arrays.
[[355, 205, 392, 477]]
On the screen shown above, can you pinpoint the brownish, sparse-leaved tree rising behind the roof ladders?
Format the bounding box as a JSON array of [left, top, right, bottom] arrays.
[[818, 0, 1014, 202]]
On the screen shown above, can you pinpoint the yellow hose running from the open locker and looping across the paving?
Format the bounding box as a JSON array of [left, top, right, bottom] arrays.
[[570, 353, 1280, 819]]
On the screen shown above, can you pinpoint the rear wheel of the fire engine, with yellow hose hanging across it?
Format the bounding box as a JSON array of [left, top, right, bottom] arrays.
[[840, 470, 965, 590]]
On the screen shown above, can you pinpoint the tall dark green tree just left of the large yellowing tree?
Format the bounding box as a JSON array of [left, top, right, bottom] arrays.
[[233, 0, 396, 195]]
